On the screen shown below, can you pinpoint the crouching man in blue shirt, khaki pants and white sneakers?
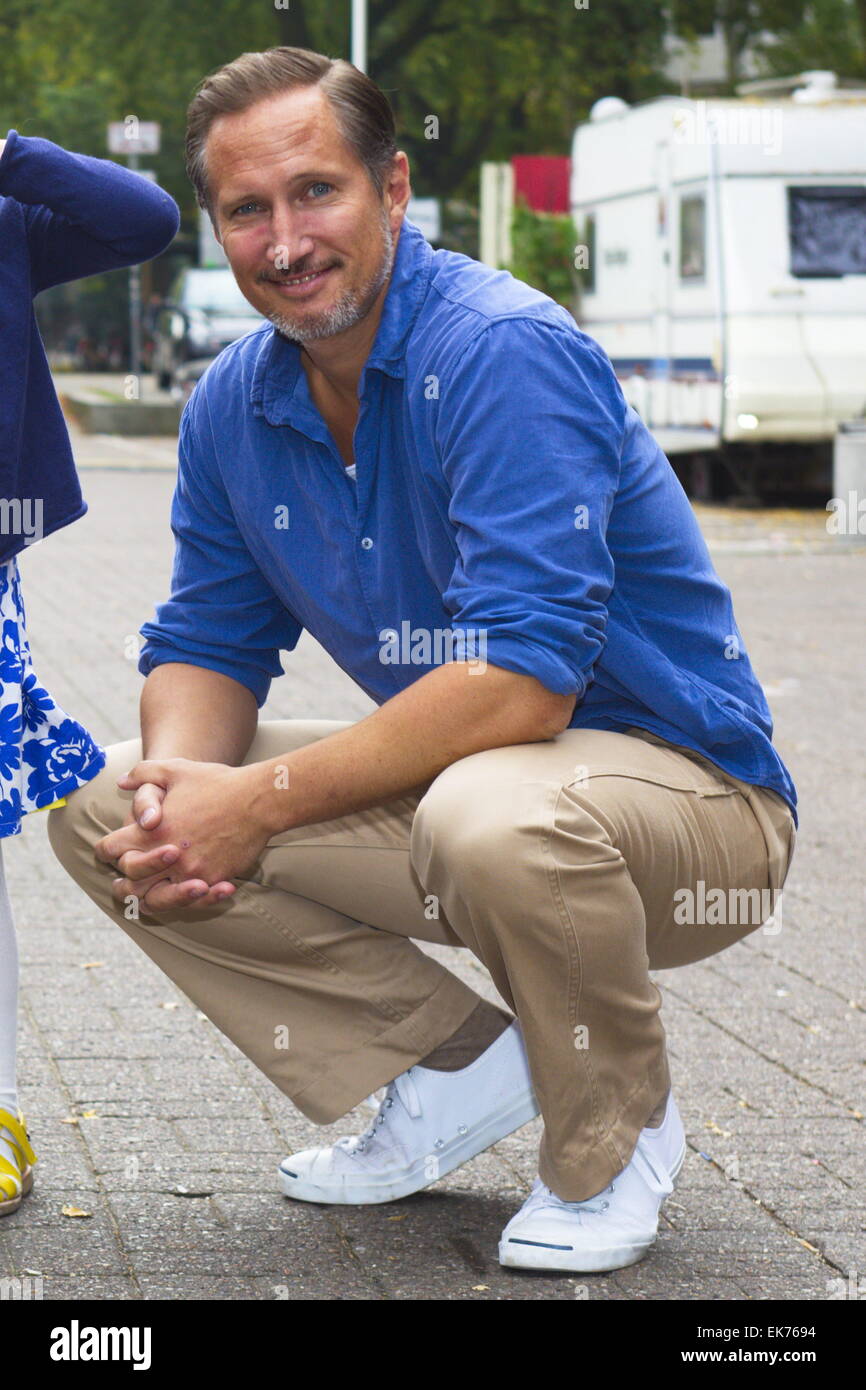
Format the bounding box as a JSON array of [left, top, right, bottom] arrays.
[[50, 49, 795, 1272]]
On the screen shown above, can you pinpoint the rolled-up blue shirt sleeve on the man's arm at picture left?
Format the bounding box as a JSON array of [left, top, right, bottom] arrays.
[[139, 386, 302, 708]]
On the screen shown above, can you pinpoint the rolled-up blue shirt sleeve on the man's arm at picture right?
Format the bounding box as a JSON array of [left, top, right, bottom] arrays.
[[436, 318, 627, 701]]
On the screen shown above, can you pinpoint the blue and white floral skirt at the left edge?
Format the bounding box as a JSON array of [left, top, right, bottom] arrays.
[[0, 556, 106, 840]]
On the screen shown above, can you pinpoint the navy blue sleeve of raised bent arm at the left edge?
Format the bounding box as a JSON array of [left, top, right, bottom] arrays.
[[0, 131, 181, 295]]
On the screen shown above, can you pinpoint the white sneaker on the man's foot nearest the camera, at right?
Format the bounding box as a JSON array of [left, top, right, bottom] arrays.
[[499, 1093, 685, 1273]]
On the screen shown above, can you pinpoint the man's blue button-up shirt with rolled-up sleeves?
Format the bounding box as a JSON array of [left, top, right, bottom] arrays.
[[139, 222, 796, 809]]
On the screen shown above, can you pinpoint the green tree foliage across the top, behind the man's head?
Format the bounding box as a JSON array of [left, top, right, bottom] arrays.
[[0, 0, 866, 225]]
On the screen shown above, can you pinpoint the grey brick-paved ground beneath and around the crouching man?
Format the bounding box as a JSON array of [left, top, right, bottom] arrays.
[[0, 469, 866, 1301]]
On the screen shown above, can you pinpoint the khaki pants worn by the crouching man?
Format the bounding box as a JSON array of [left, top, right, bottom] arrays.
[[49, 720, 795, 1201]]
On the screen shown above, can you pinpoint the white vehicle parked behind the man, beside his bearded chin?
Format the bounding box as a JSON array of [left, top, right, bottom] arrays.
[[153, 265, 263, 391]]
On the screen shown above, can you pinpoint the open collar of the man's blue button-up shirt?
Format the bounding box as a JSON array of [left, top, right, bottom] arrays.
[[250, 212, 434, 425]]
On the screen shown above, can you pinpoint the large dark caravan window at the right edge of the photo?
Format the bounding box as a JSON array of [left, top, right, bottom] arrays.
[[788, 185, 866, 277]]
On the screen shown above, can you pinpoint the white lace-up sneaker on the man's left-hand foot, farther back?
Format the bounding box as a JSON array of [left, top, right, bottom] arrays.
[[279, 1020, 538, 1205]]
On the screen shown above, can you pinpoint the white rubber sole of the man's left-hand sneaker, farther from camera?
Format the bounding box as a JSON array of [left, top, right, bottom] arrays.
[[279, 1091, 539, 1207]]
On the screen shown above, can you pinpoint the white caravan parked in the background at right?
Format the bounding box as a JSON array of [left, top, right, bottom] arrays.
[[571, 72, 866, 491]]
